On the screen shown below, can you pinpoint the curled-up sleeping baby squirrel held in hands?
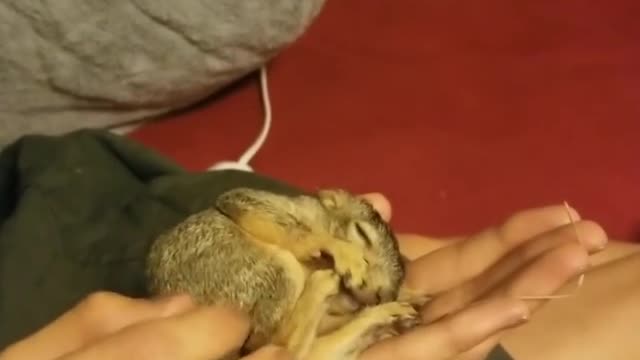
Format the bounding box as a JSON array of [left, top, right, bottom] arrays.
[[146, 188, 424, 360]]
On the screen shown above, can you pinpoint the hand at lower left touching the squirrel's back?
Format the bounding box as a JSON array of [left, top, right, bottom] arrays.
[[0, 293, 290, 360]]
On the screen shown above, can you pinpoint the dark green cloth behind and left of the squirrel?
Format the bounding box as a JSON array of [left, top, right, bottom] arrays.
[[0, 131, 512, 360]]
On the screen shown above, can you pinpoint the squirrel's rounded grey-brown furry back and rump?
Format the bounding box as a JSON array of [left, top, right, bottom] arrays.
[[147, 209, 302, 350]]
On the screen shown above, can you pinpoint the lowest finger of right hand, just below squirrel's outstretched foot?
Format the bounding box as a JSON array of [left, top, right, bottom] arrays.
[[362, 298, 528, 360]]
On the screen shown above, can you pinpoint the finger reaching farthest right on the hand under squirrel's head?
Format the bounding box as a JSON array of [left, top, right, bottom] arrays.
[[423, 221, 603, 321]]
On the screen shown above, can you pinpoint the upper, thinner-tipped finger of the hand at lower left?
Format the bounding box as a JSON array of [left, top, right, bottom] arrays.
[[2, 292, 192, 359]]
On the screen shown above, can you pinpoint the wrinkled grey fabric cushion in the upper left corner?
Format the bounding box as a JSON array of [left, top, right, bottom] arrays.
[[0, 0, 325, 147]]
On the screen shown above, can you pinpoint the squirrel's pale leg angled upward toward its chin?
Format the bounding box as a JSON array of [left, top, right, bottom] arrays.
[[272, 270, 340, 359]]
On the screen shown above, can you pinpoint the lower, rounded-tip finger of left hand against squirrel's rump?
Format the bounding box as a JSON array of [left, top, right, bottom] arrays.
[[59, 307, 249, 360]]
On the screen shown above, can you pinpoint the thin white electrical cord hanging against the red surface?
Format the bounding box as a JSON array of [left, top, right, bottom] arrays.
[[209, 66, 272, 172]]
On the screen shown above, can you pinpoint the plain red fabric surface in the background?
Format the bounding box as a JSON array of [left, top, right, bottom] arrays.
[[127, 0, 640, 240]]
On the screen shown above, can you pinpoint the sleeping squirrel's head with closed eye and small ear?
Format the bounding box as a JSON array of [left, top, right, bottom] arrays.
[[317, 189, 405, 304]]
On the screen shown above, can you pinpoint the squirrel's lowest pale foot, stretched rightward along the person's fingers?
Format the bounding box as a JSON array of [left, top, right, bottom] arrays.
[[305, 302, 419, 360]]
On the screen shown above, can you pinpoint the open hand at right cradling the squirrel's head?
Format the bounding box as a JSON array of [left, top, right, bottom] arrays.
[[362, 194, 607, 360]]
